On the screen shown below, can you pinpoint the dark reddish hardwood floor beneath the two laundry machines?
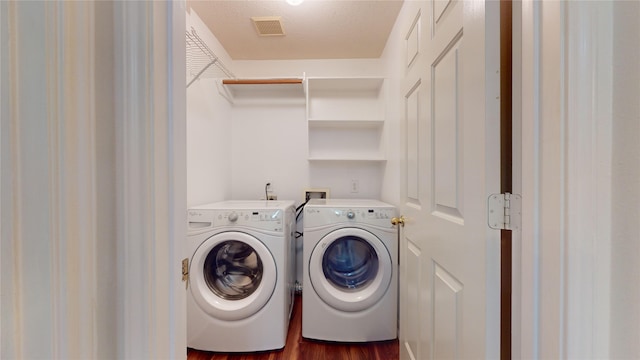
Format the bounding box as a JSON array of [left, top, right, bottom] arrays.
[[187, 296, 400, 360]]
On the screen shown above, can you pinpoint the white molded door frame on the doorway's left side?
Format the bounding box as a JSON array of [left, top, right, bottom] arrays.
[[113, 0, 187, 358]]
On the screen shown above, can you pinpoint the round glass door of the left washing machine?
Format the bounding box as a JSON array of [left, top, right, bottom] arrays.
[[189, 231, 276, 320]]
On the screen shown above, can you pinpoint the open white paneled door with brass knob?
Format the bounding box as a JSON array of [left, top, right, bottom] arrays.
[[400, 0, 500, 359]]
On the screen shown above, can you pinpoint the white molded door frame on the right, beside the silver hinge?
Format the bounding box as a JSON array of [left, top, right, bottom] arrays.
[[512, 1, 613, 358]]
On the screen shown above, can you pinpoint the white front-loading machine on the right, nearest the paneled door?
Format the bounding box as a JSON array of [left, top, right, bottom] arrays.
[[302, 199, 398, 342]]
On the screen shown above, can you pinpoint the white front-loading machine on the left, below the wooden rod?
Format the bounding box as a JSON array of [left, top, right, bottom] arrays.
[[187, 201, 295, 352]]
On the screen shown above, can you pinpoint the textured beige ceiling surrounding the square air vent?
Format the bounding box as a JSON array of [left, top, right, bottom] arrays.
[[187, 0, 402, 60]]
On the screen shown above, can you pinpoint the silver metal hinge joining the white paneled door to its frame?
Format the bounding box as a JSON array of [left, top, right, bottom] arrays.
[[487, 193, 522, 230]]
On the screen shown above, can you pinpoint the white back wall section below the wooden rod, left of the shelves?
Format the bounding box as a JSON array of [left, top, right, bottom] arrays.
[[228, 98, 308, 205]]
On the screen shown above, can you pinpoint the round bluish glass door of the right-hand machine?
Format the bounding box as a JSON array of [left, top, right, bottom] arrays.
[[309, 228, 393, 311]]
